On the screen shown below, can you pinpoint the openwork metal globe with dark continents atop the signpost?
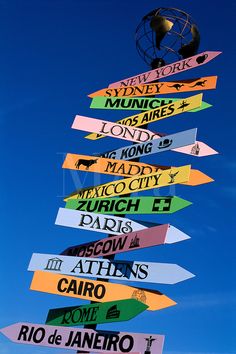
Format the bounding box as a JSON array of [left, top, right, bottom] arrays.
[[135, 7, 200, 68]]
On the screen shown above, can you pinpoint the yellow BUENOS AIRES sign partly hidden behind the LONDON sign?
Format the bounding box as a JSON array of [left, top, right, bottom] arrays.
[[85, 93, 203, 140]]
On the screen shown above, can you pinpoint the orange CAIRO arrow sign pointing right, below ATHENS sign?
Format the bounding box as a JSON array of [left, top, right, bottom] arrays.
[[30, 270, 176, 311]]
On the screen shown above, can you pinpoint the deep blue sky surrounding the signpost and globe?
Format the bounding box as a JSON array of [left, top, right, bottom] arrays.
[[0, 0, 236, 354]]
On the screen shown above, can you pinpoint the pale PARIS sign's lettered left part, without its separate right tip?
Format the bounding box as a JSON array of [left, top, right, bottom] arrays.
[[55, 208, 148, 235]]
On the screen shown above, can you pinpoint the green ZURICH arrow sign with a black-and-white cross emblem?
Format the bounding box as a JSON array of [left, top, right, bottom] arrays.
[[66, 195, 192, 215]]
